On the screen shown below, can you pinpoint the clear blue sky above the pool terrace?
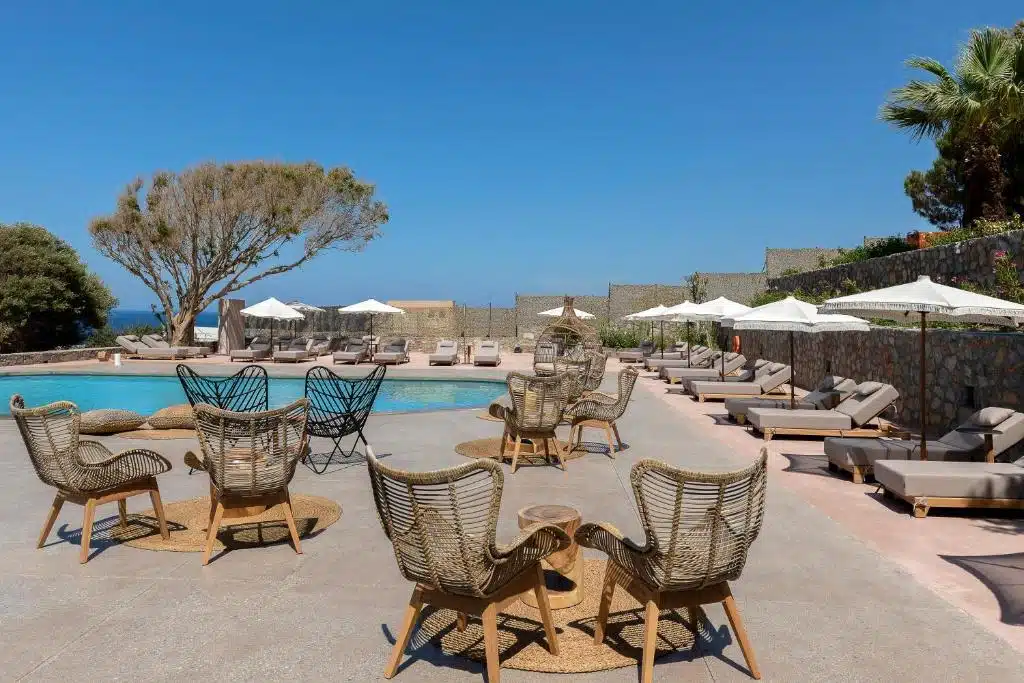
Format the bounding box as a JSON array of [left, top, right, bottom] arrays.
[[0, 0, 1024, 307]]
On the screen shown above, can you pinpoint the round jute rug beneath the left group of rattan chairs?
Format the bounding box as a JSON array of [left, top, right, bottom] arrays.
[[110, 494, 341, 553]]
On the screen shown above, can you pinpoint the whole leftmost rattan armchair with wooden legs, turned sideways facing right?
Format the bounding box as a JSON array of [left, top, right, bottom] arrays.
[[10, 394, 171, 563]]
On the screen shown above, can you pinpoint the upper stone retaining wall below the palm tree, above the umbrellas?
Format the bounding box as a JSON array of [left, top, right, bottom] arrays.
[[768, 230, 1024, 292]]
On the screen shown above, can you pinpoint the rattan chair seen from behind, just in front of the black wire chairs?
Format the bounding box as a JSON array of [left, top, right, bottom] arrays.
[[193, 398, 309, 564]]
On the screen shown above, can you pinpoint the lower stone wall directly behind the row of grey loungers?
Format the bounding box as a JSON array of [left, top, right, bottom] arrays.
[[739, 327, 1024, 440]]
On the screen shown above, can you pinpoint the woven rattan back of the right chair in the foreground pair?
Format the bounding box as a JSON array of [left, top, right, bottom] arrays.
[[630, 452, 767, 591]]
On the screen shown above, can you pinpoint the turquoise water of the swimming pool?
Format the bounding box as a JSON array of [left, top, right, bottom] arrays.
[[0, 375, 505, 415]]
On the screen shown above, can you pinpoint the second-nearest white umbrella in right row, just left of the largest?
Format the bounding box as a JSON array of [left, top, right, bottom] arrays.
[[721, 296, 868, 410]]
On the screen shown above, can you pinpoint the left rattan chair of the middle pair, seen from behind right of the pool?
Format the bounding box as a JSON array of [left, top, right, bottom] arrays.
[[498, 373, 568, 474]]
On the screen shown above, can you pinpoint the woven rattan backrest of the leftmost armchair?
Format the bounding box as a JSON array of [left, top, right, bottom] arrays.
[[10, 394, 83, 490]]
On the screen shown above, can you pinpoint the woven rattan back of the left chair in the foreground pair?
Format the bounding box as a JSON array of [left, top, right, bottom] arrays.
[[367, 458, 504, 597]]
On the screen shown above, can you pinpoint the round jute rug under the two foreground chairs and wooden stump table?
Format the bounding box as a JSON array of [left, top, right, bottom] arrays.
[[417, 560, 711, 674]]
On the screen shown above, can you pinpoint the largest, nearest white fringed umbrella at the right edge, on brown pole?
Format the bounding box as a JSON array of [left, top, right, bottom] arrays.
[[819, 275, 1024, 460]]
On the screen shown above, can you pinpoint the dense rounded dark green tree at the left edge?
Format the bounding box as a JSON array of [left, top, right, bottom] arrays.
[[0, 223, 117, 352]]
